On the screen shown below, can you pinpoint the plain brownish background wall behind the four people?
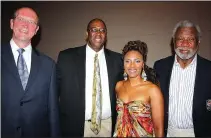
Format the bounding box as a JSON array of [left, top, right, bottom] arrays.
[[1, 1, 211, 66]]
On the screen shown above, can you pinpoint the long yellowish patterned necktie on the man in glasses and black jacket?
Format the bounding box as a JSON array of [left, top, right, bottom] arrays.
[[91, 54, 102, 135]]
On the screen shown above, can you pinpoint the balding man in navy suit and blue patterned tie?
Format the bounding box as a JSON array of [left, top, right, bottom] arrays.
[[1, 7, 60, 137]]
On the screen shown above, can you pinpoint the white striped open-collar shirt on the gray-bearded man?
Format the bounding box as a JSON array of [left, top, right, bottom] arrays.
[[168, 55, 197, 129]]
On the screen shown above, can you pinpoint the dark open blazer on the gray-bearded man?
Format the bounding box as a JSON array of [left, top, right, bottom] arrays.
[[154, 55, 211, 137]]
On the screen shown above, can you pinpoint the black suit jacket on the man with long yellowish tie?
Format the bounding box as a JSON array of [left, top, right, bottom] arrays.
[[57, 45, 123, 136]]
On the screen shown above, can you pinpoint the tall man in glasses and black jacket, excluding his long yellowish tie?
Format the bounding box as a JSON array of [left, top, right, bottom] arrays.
[[58, 19, 123, 137]]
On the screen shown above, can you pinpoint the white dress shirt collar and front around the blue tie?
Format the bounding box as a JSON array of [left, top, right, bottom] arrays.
[[10, 39, 32, 73]]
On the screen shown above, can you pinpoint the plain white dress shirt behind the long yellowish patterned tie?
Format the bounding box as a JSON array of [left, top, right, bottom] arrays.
[[85, 44, 111, 120]]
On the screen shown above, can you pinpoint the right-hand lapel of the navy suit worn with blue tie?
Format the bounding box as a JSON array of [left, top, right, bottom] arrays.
[[25, 50, 40, 93]]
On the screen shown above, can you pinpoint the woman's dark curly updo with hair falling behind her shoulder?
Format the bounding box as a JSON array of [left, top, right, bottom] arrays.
[[122, 40, 159, 85]]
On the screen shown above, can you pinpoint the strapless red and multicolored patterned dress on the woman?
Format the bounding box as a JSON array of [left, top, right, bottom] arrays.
[[113, 99, 154, 137]]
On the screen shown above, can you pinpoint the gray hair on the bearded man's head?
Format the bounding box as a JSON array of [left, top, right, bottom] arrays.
[[172, 20, 201, 41]]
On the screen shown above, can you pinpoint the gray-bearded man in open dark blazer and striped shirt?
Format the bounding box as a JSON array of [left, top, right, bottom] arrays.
[[154, 20, 211, 137]]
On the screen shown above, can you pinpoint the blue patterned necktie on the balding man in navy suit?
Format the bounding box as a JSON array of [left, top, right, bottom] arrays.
[[17, 48, 29, 90]]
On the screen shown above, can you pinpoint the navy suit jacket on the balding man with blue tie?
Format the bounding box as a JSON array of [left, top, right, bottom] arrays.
[[1, 44, 59, 137]]
